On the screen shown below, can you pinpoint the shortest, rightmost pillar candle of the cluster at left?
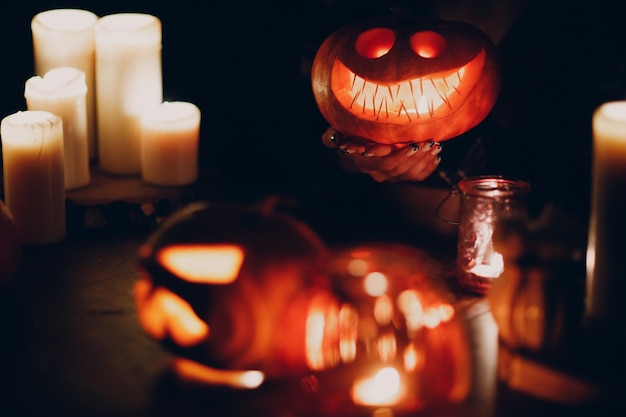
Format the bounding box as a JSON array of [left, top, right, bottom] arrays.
[[141, 101, 200, 186]]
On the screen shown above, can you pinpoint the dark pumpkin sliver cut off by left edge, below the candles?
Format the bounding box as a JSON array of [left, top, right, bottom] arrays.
[[0, 200, 22, 286]]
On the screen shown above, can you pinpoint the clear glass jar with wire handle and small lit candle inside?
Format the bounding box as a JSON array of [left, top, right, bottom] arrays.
[[456, 176, 530, 294]]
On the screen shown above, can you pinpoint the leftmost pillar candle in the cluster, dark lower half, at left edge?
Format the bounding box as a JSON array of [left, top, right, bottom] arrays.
[[0, 110, 66, 245]]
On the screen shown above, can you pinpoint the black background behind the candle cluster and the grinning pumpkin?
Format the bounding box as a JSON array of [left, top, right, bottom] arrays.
[[0, 0, 626, 223]]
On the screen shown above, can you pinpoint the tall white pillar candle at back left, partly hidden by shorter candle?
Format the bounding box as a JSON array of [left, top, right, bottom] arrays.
[[31, 9, 98, 161]]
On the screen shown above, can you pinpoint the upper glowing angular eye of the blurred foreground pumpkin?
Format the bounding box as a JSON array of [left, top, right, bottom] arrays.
[[157, 244, 244, 284]]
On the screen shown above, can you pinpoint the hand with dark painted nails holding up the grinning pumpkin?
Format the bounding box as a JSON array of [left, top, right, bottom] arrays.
[[322, 128, 442, 182]]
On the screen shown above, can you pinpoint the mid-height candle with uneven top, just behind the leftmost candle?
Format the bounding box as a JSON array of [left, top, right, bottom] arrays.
[[24, 67, 90, 190]]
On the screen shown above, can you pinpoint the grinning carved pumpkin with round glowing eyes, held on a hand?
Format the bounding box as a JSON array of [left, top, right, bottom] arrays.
[[311, 17, 500, 144]]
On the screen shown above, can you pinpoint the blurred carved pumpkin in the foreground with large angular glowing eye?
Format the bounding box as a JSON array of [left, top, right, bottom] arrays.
[[135, 199, 326, 376]]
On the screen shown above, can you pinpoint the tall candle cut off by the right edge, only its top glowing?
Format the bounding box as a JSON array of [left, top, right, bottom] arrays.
[[585, 101, 626, 329]]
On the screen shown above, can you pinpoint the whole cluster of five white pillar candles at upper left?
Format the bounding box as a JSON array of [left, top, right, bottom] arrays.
[[0, 9, 200, 244]]
